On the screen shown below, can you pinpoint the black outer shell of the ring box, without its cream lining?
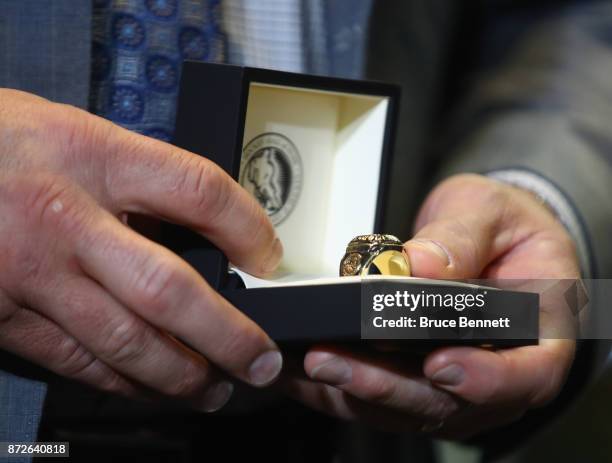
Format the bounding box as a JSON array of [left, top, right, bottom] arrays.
[[169, 62, 537, 347]]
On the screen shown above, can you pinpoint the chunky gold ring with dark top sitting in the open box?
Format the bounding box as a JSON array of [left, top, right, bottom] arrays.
[[340, 235, 410, 277]]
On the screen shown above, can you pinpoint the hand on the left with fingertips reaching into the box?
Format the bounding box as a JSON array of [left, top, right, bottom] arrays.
[[0, 89, 282, 411]]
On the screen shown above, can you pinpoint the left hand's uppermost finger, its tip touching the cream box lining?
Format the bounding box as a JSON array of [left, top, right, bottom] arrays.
[[98, 123, 282, 275]]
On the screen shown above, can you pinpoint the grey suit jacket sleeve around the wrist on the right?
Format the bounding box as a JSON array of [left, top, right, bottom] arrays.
[[436, 1, 612, 453]]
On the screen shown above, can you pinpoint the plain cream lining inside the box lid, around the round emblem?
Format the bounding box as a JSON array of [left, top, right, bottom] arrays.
[[243, 83, 388, 281]]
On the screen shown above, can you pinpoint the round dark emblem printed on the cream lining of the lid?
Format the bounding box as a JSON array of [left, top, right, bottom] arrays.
[[240, 133, 302, 225]]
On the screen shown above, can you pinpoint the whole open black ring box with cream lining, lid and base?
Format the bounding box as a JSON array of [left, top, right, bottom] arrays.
[[164, 62, 538, 346]]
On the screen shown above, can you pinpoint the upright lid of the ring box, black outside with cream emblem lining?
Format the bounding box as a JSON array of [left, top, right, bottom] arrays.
[[174, 62, 399, 289]]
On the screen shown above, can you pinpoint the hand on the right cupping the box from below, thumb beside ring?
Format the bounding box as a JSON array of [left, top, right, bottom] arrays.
[[281, 175, 580, 439]]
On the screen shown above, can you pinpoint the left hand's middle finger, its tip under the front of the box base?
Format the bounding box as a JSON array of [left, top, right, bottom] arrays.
[[75, 210, 282, 386]]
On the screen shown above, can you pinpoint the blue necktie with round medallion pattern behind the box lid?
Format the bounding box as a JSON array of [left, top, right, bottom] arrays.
[[90, 0, 227, 141]]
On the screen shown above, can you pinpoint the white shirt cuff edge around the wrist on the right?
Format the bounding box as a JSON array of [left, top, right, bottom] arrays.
[[485, 168, 592, 278]]
